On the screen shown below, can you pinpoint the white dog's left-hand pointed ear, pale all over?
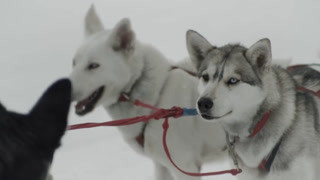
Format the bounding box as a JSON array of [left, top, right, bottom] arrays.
[[85, 4, 104, 36]]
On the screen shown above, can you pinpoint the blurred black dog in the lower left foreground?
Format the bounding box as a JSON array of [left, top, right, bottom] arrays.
[[0, 79, 71, 180]]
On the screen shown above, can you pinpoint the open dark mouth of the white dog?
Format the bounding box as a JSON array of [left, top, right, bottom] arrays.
[[76, 86, 104, 116]]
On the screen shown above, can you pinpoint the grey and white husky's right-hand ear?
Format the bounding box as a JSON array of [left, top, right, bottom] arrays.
[[245, 38, 272, 73]]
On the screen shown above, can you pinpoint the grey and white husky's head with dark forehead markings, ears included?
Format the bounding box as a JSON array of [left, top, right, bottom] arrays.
[[187, 31, 271, 121]]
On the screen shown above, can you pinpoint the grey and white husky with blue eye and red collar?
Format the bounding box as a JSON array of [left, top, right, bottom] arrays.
[[187, 30, 320, 180]]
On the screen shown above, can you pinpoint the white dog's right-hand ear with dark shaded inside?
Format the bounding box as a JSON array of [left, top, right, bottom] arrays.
[[110, 18, 135, 53]]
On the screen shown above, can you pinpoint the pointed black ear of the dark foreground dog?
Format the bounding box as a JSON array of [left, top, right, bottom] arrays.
[[28, 79, 71, 141]]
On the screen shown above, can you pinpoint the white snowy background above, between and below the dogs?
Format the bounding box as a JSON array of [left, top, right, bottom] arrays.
[[0, 0, 320, 180]]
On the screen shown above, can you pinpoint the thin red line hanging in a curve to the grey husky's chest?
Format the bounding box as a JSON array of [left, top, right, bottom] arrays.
[[162, 118, 242, 176]]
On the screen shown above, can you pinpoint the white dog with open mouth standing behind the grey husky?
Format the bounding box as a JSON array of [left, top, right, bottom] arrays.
[[70, 7, 225, 180]]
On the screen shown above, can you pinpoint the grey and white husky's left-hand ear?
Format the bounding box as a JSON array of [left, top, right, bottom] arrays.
[[186, 30, 215, 69]]
